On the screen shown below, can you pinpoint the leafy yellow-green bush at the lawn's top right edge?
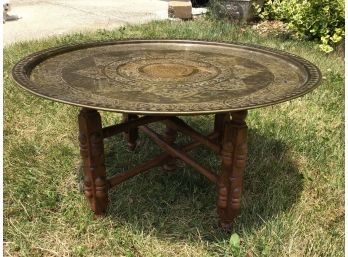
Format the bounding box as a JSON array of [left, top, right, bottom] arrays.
[[257, 0, 344, 52]]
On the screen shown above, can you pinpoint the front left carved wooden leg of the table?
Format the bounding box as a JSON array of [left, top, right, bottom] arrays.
[[78, 108, 109, 215]]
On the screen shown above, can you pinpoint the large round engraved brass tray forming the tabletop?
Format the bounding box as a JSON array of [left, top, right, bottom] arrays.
[[12, 40, 321, 115]]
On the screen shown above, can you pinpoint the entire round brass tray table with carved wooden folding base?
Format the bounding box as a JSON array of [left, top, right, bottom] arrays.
[[12, 40, 321, 228]]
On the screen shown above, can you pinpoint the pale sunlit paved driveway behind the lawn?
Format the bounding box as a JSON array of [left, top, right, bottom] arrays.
[[3, 0, 168, 45]]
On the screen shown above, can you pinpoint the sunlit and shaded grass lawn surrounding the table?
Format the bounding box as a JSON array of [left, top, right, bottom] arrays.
[[4, 19, 344, 257]]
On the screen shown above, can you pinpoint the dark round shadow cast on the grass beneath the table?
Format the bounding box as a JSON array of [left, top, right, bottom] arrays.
[[102, 119, 303, 241]]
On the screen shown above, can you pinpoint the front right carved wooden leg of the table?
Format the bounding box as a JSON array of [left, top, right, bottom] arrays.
[[217, 111, 248, 229]]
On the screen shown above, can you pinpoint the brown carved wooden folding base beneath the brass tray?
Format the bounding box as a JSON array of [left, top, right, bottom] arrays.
[[78, 108, 247, 229]]
